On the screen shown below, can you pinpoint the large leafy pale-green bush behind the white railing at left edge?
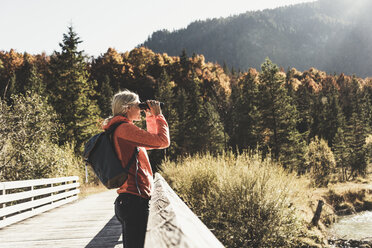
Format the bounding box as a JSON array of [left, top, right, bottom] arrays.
[[0, 93, 83, 181]]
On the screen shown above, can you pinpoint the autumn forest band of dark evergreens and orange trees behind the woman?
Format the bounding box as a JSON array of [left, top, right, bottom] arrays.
[[0, 26, 372, 185]]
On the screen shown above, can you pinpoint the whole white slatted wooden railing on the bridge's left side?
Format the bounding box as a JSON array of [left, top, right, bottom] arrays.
[[0, 176, 80, 228]]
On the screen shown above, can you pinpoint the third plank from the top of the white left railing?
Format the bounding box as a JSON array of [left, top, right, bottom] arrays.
[[0, 189, 80, 217]]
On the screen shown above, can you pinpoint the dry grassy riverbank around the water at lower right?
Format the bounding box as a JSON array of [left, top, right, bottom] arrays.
[[305, 178, 372, 248]]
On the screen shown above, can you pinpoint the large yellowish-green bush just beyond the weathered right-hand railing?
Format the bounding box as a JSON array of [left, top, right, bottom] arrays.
[[162, 153, 307, 247]]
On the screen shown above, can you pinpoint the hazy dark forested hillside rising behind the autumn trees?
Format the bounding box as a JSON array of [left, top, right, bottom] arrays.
[[143, 0, 372, 77]]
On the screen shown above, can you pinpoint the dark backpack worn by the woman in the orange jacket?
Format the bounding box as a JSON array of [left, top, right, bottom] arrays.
[[83, 122, 139, 189]]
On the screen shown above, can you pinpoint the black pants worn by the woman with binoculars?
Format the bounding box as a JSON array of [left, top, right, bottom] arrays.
[[115, 193, 149, 248]]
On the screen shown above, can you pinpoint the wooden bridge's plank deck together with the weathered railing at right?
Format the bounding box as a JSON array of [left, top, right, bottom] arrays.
[[0, 174, 223, 248]]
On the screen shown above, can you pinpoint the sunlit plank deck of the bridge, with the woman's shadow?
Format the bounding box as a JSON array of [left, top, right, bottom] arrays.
[[0, 190, 122, 248]]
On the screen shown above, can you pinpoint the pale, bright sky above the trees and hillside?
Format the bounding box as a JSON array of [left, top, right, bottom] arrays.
[[0, 0, 314, 57]]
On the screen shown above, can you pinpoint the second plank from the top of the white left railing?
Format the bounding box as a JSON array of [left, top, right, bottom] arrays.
[[0, 183, 80, 204]]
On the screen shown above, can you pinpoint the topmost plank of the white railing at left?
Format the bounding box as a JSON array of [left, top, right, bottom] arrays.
[[0, 176, 79, 190]]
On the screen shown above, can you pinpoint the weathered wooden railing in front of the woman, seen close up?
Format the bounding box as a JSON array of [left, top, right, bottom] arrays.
[[145, 173, 224, 248]]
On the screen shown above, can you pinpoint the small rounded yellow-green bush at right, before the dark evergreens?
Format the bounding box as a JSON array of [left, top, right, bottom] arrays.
[[305, 137, 336, 186]]
